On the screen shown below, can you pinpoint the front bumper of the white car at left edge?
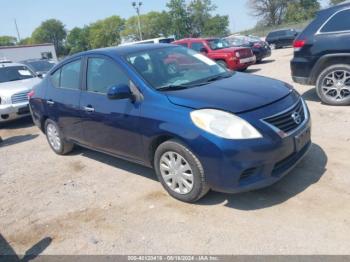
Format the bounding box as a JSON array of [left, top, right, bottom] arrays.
[[0, 102, 30, 122]]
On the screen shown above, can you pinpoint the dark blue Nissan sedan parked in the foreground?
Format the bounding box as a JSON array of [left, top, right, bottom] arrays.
[[29, 44, 311, 202]]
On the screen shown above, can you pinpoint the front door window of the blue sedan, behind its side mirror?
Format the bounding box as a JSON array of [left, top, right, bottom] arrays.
[[87, 58, 129, 94]]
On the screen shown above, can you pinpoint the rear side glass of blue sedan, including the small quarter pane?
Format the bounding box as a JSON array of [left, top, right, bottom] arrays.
[[51, 59, 81, 90]]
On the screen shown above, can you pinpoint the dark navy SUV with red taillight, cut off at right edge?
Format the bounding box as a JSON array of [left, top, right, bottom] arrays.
[[291, 2, 350, 105]]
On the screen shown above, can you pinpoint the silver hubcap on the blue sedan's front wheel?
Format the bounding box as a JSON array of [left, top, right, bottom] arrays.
[[159, 152, 194, 195]]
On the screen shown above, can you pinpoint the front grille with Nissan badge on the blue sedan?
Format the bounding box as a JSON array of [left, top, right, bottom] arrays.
[[264, 99, 306, 134]]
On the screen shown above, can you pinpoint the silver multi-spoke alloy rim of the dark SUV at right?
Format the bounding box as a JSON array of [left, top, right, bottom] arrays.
[[322, 70, 350, 101]]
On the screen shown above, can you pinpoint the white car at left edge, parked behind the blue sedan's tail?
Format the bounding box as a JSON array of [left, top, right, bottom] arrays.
[[0, 63, 41, 122]]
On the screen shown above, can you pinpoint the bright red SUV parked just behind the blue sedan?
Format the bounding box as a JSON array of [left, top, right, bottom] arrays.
[[172, 38, 256, 71]]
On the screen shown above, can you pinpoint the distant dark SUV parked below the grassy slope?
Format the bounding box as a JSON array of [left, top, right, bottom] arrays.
[[266, 29, 299, 49]]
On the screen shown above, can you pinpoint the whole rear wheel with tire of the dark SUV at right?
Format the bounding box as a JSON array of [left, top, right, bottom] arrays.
[[316, 64, 350, 106]]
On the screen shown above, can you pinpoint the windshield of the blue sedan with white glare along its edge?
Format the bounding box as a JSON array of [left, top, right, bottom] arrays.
[[125, 46, 231, 91]]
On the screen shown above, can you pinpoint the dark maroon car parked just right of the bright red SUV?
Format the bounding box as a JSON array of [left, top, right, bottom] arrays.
[[225, 35, 271, 63]]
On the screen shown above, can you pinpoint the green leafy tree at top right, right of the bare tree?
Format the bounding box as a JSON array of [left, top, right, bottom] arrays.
[[285, 0, 321, 22]]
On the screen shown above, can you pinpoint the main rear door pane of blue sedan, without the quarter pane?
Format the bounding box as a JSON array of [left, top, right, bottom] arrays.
[[60, 60, 81, 89]]
